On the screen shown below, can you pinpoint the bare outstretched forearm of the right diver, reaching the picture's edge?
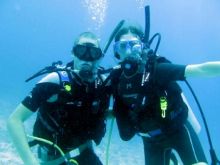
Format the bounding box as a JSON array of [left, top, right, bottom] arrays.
[[185, 61, 220, 78]]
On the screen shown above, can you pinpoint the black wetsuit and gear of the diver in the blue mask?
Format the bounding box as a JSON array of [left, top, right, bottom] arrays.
[[111, 59, 206, 165]]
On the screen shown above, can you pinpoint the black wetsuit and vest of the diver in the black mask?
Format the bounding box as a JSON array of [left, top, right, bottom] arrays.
[[22, 72, 109, 165]]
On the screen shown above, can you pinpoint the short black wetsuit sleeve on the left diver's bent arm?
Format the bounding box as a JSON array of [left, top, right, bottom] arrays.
[[22, 82, 60, 112]]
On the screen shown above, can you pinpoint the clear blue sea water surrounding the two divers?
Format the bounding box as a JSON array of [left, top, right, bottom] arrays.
[[0, 0, 220, 165]]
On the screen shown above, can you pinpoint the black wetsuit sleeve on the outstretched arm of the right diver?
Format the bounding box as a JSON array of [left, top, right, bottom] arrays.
[[154, 63, 186, 84]]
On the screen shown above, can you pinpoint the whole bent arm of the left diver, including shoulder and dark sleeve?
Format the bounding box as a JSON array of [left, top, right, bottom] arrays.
[[7, 72, 60, 165]]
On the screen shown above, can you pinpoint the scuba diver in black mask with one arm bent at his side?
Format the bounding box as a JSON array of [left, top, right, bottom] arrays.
[[7, 32, 109, 165]]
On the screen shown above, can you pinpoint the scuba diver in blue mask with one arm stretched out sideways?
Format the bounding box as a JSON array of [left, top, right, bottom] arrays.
[[109, 22, 220, 165]]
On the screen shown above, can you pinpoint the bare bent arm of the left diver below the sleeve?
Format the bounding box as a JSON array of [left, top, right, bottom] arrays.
[[7, 104, 39, 165]]
